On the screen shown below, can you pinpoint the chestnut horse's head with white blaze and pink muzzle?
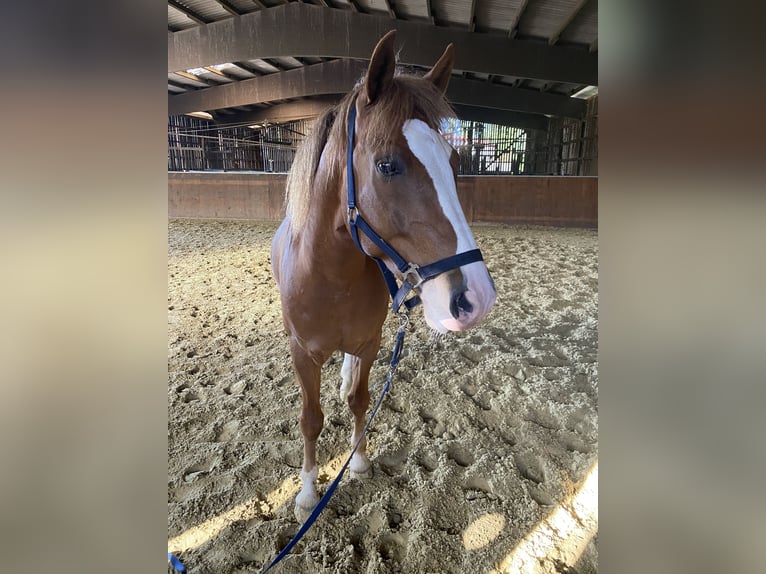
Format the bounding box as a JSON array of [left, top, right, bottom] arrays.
[[351, 31, 496, 333]]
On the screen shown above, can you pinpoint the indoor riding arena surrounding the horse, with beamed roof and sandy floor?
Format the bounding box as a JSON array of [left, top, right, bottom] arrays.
[[167, 0, 599, 574]]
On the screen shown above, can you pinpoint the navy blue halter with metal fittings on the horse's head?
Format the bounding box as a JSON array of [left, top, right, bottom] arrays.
[[346, 101, 484, 313]]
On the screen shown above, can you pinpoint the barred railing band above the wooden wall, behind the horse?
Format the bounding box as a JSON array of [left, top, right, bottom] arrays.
[[168, 97, 598, 175]]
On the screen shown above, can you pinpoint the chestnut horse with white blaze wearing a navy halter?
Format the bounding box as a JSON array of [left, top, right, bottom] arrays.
[[271, 31, 495, 517]]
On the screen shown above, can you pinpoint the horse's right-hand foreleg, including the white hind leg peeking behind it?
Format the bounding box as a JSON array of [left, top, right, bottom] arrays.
[[341, 341, 380, 478]]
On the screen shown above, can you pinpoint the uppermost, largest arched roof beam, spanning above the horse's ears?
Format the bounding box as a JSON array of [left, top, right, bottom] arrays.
[[168, 2, 598, 85]]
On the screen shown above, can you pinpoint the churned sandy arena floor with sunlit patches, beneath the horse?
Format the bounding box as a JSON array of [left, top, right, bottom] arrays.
[[168, 220, 598, 574]]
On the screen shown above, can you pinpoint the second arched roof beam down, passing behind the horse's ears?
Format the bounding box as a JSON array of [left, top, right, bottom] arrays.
[[168, 60, 586, 118]]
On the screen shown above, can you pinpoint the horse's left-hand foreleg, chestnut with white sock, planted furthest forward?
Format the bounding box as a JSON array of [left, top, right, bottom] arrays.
[[290, 339, 324, 521]]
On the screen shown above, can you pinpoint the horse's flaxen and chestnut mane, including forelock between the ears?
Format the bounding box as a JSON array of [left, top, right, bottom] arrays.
[[285, 72, 455, 234]]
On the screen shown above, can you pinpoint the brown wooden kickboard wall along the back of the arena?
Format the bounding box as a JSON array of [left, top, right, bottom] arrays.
[[168, 172, 598, 227]]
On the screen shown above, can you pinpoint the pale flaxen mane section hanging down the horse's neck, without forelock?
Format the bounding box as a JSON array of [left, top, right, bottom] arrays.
[[285, 106, 337, 228]]
